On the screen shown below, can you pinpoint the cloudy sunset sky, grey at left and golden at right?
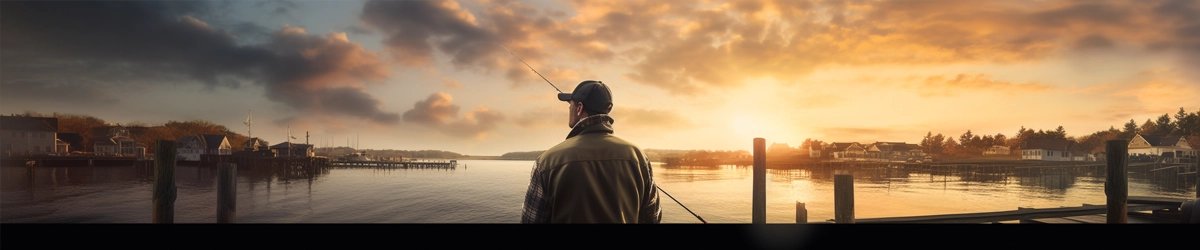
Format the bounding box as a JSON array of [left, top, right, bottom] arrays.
[[0, 0, 1200, 155]]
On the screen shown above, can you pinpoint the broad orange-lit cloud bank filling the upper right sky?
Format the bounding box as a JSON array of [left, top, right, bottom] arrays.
[[609, 0, 1200, 95]]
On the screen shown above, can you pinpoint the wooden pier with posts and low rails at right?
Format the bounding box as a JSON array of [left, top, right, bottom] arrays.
[[751, 138, 1200, 224]]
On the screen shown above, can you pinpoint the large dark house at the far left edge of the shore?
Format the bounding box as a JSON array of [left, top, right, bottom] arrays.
[[0, 115, 59, 155]]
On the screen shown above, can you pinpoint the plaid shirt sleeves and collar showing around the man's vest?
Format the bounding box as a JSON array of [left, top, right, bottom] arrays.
[[521, 114, 662, 224]]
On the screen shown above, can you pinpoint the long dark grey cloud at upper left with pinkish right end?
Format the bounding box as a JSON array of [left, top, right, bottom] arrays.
[[0, 1, 400, 124]]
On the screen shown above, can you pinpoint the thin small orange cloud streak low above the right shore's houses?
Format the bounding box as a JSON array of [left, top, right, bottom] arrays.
[[904, 73, 1054, 97]]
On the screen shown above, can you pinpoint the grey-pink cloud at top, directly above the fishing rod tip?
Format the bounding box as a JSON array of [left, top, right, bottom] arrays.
[[360, 0, 604, 87]]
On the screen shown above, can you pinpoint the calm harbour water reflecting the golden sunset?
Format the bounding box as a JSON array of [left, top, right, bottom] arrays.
[[0, 160, 1195, 224]]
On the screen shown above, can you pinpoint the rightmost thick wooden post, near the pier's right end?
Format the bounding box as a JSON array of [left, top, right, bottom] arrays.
[[1104, 139, 1129, 224]]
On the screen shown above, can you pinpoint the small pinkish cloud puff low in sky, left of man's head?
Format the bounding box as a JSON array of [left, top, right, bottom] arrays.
[[403, 93, 505, 139]]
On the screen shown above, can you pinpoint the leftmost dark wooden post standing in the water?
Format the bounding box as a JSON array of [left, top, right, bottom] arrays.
[[154, 139, 178, 224]]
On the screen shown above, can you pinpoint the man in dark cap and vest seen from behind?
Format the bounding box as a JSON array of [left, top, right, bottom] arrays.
[[521, 81, 662, 224]]
